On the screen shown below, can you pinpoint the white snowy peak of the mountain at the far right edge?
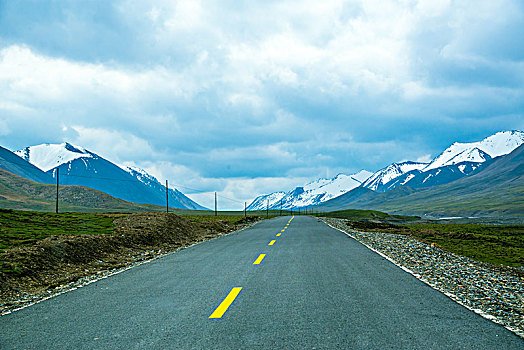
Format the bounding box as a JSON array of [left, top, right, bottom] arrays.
[[422, 130, 524, 171]]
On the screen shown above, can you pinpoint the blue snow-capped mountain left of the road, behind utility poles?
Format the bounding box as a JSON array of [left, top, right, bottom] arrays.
[[16, 143, 205, 209]]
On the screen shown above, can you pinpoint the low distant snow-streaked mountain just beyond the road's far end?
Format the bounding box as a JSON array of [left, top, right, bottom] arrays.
[[247, 170, 372, 210]]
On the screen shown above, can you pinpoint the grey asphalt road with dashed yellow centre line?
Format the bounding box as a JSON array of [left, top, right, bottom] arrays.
[[0, 217, 524, 349]]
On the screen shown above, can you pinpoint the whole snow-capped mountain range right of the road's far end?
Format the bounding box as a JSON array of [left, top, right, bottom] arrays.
[[249, 130, 524, 215]]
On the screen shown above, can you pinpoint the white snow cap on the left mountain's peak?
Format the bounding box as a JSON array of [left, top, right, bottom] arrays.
[[15, 142, 96, 171]]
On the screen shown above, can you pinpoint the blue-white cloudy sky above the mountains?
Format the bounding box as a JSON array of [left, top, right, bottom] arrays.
[[0, 0, 524, 208]]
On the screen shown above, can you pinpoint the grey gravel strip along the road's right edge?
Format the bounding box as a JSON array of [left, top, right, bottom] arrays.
[[323, 218, 524, 338]]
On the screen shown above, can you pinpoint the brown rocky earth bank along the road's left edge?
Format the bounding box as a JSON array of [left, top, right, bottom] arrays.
[[0, 212, 258, 314]]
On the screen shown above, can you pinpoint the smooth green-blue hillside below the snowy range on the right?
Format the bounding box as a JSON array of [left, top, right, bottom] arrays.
[[319, 145, 524, 216]]
